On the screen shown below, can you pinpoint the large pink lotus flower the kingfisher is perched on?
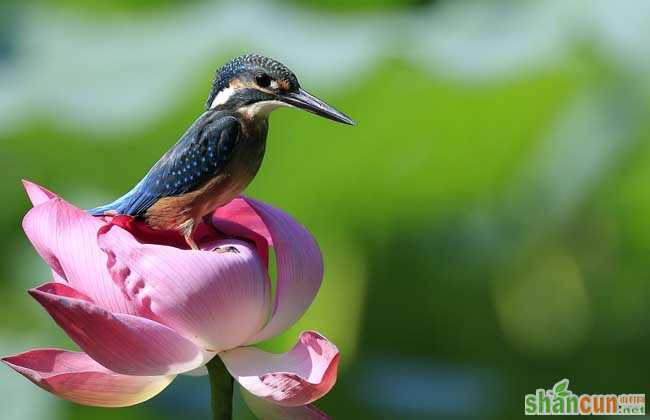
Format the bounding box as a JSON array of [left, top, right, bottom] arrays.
[[2, 182, 339, 418]]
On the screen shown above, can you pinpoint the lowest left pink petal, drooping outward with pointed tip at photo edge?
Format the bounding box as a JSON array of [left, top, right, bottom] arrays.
[[2, 349, 174, 407]]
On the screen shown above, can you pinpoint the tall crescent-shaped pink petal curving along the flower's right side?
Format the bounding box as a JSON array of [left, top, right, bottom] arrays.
[[233, 198, 323, 344]]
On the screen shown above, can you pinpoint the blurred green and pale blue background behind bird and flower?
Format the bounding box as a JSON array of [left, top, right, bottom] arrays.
[[0, 0, 650, 420]]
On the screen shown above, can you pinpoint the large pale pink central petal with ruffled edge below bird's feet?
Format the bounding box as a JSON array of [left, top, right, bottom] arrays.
[[99, 226, 270, 352]]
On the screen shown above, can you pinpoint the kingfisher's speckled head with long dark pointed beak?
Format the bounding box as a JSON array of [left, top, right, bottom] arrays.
[[205, 54, 355, 125]]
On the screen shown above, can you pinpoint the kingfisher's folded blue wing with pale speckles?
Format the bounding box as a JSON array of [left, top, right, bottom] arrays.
[[89, 116, 240, 216]]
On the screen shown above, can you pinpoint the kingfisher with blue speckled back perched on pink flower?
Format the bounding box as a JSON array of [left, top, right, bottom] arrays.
[[88, 54, 356, 249]]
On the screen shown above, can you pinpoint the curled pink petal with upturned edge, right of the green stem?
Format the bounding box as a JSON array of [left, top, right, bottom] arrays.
[[220, 331, 339, 407]]
